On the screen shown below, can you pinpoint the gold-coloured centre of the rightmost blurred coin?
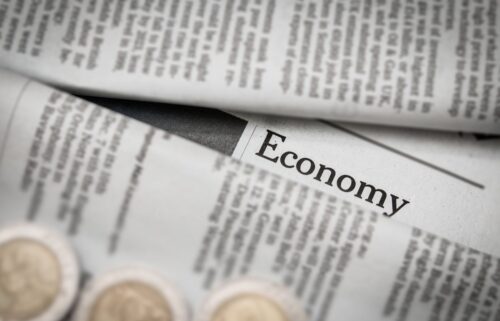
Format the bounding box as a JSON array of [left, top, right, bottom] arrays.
[[212, 294, 287, 321]]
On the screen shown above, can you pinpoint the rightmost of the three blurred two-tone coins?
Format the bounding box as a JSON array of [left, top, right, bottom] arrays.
[[197, 278, 306, 321]]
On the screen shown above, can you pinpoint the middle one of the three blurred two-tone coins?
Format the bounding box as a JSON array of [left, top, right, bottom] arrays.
[[74, 268, 189, 321]]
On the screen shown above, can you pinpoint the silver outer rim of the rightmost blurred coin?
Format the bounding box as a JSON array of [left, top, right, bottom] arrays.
[[195, 277, 307, 321]]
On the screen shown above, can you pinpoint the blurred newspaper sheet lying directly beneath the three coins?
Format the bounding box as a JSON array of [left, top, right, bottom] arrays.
[[0, 72, 500, 321]]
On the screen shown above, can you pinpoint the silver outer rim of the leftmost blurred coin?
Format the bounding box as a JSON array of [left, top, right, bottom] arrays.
[[0, 224, 80, 321]]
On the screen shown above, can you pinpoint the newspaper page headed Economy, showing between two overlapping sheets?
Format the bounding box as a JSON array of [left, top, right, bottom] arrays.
[[84, 97, 500, 256]]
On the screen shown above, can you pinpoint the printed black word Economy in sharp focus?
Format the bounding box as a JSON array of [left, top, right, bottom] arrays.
[[255, 130, 410, 217]]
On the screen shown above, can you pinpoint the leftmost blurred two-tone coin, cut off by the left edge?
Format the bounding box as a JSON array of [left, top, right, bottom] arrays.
[[0, 224, 80, 321]]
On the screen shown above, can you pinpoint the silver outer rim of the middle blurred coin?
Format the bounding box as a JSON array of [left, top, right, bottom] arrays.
[[72, 267, 190, 321]]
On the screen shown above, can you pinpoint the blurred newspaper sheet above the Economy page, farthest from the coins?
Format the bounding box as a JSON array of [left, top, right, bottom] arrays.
[[0, 0, 500, 134]]
